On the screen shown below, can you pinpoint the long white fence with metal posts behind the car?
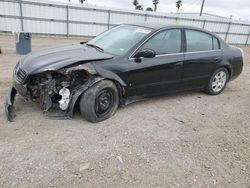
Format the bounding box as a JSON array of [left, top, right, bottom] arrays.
[[0, 0, 250, 44]]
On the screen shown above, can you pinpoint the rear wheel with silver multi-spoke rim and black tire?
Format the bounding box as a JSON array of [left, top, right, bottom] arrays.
[[205, 67, 229, 95]]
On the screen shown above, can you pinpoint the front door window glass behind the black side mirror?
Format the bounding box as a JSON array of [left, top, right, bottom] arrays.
[[142, 29, 181, 55]]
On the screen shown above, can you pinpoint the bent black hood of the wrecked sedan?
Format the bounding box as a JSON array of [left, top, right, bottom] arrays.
[[20, 44, 113, 74]]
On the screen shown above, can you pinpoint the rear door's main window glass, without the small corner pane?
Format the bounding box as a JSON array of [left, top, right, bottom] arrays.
[[186, 30, 213, 52]]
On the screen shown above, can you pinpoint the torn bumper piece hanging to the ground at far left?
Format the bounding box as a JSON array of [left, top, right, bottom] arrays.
[[5, 87, 17, 121]]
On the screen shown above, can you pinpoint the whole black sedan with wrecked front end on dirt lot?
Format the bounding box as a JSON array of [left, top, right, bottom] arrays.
[[5, 23, 243, 122]]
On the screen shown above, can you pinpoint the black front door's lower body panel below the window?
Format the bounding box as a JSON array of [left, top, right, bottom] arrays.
[[127, 53, 184, 96]]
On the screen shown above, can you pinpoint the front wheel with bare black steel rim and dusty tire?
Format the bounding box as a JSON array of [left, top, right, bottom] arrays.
[[80, 80, 119, 123]]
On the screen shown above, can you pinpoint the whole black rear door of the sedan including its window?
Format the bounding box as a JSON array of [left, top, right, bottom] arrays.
[[183, 29, 222, 89]]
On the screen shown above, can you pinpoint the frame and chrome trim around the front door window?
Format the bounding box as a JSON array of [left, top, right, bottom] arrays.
[[129, 28, 184, 59]]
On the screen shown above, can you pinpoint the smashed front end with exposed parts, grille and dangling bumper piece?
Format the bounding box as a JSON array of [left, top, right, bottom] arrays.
[[5, 63, 103, 121]]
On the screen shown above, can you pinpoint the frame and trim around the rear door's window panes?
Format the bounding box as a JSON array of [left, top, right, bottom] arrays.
[[183, 28, 221, 54]]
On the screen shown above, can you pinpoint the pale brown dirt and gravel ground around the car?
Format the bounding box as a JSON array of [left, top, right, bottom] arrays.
[[0, 35, 250, 188]]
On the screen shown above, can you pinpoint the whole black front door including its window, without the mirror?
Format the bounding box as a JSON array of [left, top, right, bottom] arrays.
[[127, 29, 184, 96]]
